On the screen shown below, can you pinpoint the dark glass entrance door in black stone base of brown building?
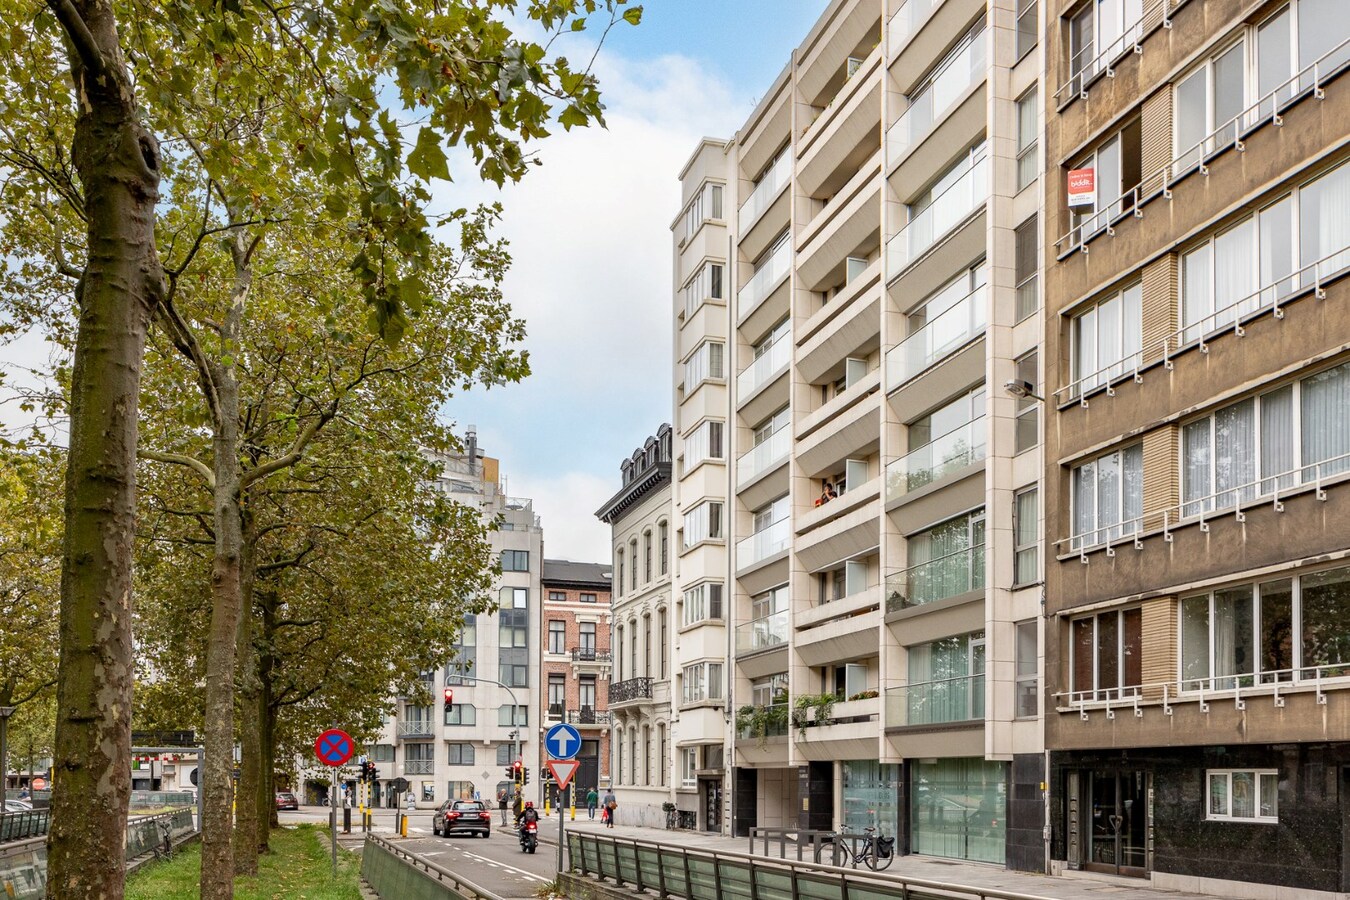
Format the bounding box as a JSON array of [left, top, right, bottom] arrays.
[[1083, 769, 1153, 877]]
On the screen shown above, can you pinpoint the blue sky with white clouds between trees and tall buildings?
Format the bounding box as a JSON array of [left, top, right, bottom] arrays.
[[446, 0, 826, 561]]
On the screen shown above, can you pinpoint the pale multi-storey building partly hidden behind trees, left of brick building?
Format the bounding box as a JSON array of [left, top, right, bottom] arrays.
[[369, 442, 543, 810]]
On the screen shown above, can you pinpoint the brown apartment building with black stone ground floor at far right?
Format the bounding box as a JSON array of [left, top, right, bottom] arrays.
[[1042, 0, 1350, 899]]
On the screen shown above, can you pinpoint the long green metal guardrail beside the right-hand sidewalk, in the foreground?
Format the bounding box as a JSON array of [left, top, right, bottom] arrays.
[[567, 831, 1049, 900]]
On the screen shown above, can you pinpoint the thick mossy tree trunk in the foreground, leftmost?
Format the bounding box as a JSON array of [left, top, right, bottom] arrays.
[[47, 0, 163, 900]]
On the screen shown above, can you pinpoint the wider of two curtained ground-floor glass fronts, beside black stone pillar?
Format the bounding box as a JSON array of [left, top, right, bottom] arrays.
[[912, 758, 1007, 865]]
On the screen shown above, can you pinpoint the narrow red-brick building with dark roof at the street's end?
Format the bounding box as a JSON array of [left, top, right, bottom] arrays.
[[537, 560, 613, 806]]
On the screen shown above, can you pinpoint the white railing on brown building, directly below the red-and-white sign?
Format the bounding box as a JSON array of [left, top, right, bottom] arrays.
[[1054, 38, 1350, 256]]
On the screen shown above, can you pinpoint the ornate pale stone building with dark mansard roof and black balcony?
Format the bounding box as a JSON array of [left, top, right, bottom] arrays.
[[595, 425, 680, 828]]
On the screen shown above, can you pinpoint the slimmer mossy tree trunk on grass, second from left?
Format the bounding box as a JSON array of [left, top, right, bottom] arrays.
[[201, 229, 252, 900]]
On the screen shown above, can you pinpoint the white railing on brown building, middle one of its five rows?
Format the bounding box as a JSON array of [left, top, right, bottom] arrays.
[[1054, 246, 1350, 406]]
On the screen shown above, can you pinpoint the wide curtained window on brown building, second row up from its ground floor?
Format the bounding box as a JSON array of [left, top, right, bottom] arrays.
[[1181, 363, 1350, 515]]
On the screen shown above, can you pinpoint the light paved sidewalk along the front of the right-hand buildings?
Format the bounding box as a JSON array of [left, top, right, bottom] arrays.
[[539, 814, 1214, 900]]
